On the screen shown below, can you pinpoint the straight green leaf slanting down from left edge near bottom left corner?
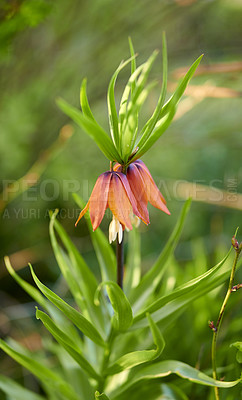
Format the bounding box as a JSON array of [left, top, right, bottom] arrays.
[[0, 339, 79, 400]]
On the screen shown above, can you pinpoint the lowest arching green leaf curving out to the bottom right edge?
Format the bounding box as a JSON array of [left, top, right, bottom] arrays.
[[111, 360, 241, 400]]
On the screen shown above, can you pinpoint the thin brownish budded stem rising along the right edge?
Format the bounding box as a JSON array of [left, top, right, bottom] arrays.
[[212, 245, 241, 400]]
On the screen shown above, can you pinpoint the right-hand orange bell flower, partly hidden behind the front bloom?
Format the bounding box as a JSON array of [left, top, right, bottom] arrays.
[[114, 160, 170, 224]]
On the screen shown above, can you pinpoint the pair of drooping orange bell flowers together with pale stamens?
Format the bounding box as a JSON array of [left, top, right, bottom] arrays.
[[76, 160, 170, 243]]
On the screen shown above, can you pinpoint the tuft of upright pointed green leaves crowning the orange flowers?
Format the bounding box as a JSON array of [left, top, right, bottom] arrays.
[[57, 34, 202, 165]]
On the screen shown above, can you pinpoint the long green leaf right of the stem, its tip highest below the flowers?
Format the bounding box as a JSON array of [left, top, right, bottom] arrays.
[[130, 199, 191, 310]]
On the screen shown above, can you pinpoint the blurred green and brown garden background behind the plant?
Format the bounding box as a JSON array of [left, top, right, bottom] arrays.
[[0, 0, 242, 399]]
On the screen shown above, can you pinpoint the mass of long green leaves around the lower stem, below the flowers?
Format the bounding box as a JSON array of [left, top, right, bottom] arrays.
[[0, 205, 241, 400]]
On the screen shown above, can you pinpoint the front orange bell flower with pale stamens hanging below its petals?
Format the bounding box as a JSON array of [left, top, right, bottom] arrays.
[[76, 171, 145, 233]]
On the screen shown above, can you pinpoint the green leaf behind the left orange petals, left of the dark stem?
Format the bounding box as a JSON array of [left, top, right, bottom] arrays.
[[73, 193, 117, 281]]
